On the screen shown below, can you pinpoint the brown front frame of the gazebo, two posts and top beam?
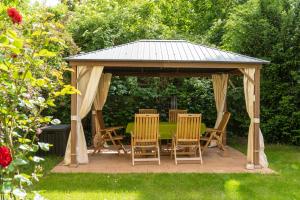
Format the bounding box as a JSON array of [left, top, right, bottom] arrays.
[[67, 39, 268, 167]]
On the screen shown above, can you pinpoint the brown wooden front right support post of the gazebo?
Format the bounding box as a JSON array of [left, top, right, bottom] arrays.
[[253, 66, 260, 167]]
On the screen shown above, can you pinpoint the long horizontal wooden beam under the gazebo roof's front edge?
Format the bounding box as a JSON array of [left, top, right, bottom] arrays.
[[70, 60, 261, 69]]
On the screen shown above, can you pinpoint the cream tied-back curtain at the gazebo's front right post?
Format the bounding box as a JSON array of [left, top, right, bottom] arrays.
[[244, 68, 268, 167]]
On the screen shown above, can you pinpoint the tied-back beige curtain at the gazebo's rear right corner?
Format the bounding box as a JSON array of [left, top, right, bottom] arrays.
[[212, 74, 228, 128]]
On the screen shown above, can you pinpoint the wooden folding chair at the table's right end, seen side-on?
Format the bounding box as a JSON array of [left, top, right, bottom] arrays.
[[201, 112, 231, 153]]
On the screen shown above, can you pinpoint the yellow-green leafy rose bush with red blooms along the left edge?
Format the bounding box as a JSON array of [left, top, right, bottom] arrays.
[[0, 3, 77, 199]]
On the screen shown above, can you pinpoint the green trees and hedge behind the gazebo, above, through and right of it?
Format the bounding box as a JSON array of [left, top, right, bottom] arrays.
[[67, 0, 300, 144]]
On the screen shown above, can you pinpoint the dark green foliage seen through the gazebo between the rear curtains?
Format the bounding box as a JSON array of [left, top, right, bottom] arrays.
[[103, 77, 216, 125]]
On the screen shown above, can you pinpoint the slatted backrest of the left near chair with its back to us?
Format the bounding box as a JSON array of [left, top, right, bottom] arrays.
[[133, 114, 159, 142]]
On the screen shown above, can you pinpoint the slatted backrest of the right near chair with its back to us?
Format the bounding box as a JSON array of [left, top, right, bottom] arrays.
[[176, 114, 201, 141]]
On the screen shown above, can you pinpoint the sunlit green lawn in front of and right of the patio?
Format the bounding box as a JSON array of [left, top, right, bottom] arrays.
[[35, 145, 300, 200]]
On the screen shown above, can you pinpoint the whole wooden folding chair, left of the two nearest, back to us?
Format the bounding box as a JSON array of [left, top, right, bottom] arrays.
[[131, 114, 160, 166]]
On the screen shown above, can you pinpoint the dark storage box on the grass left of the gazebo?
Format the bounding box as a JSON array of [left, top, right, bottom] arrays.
[[38, 124, 71, 156]]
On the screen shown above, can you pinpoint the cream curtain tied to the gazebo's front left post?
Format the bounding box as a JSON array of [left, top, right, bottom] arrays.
[[64, 66, 103, 165]]
